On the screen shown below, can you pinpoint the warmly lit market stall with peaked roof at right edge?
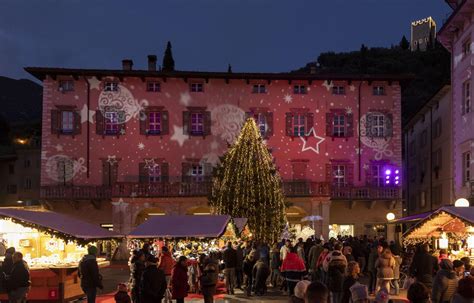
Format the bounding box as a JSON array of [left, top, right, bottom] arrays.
[[403, 206, 474, 261]]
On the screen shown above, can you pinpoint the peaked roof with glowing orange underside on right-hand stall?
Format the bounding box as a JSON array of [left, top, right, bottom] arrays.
[[403, 206, 474, 241]]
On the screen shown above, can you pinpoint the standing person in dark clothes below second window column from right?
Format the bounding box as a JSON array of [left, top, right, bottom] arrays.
[[323, 242, 347, 302]]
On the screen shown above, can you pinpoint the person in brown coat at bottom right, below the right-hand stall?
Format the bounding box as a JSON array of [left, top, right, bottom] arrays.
[[431, 259, 458, 303]]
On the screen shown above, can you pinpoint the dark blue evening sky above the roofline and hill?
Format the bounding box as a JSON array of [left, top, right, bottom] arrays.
[[0, 0, 450, 78]]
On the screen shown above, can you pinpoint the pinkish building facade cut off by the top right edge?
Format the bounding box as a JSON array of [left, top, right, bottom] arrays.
[[438, 0, 474, 205]]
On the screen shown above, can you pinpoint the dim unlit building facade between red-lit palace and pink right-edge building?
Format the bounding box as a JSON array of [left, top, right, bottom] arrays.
[[403, 85, 454, 216]]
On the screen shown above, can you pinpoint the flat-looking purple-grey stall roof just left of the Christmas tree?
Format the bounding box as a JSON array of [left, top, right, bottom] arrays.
[[128, 215, 230, 238]]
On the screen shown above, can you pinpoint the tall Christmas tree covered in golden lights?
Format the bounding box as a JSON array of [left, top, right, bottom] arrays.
[[209, 118, 286, 243]]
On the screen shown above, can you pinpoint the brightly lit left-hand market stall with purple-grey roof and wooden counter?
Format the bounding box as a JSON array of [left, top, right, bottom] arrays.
[[0, 208, 120, 302]]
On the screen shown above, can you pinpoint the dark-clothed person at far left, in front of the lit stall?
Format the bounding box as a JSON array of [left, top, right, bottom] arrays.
[[6, 251, 31, 303]]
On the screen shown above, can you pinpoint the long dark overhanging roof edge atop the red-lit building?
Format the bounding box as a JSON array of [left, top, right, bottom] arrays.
[[25, 67, 413, 81]]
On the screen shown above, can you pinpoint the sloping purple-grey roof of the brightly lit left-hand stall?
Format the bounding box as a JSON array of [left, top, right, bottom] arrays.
[[0, 208, 121, 240]]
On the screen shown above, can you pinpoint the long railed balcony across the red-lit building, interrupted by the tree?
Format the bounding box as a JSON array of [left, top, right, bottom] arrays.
[[41, 180, 400, 200]]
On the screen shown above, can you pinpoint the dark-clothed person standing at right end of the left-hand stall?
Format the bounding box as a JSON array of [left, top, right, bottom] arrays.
[[78, 245, 104, 303]]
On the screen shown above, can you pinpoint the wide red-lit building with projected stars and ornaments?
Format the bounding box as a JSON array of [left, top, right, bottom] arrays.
[[26, 56, 402, 238]]
